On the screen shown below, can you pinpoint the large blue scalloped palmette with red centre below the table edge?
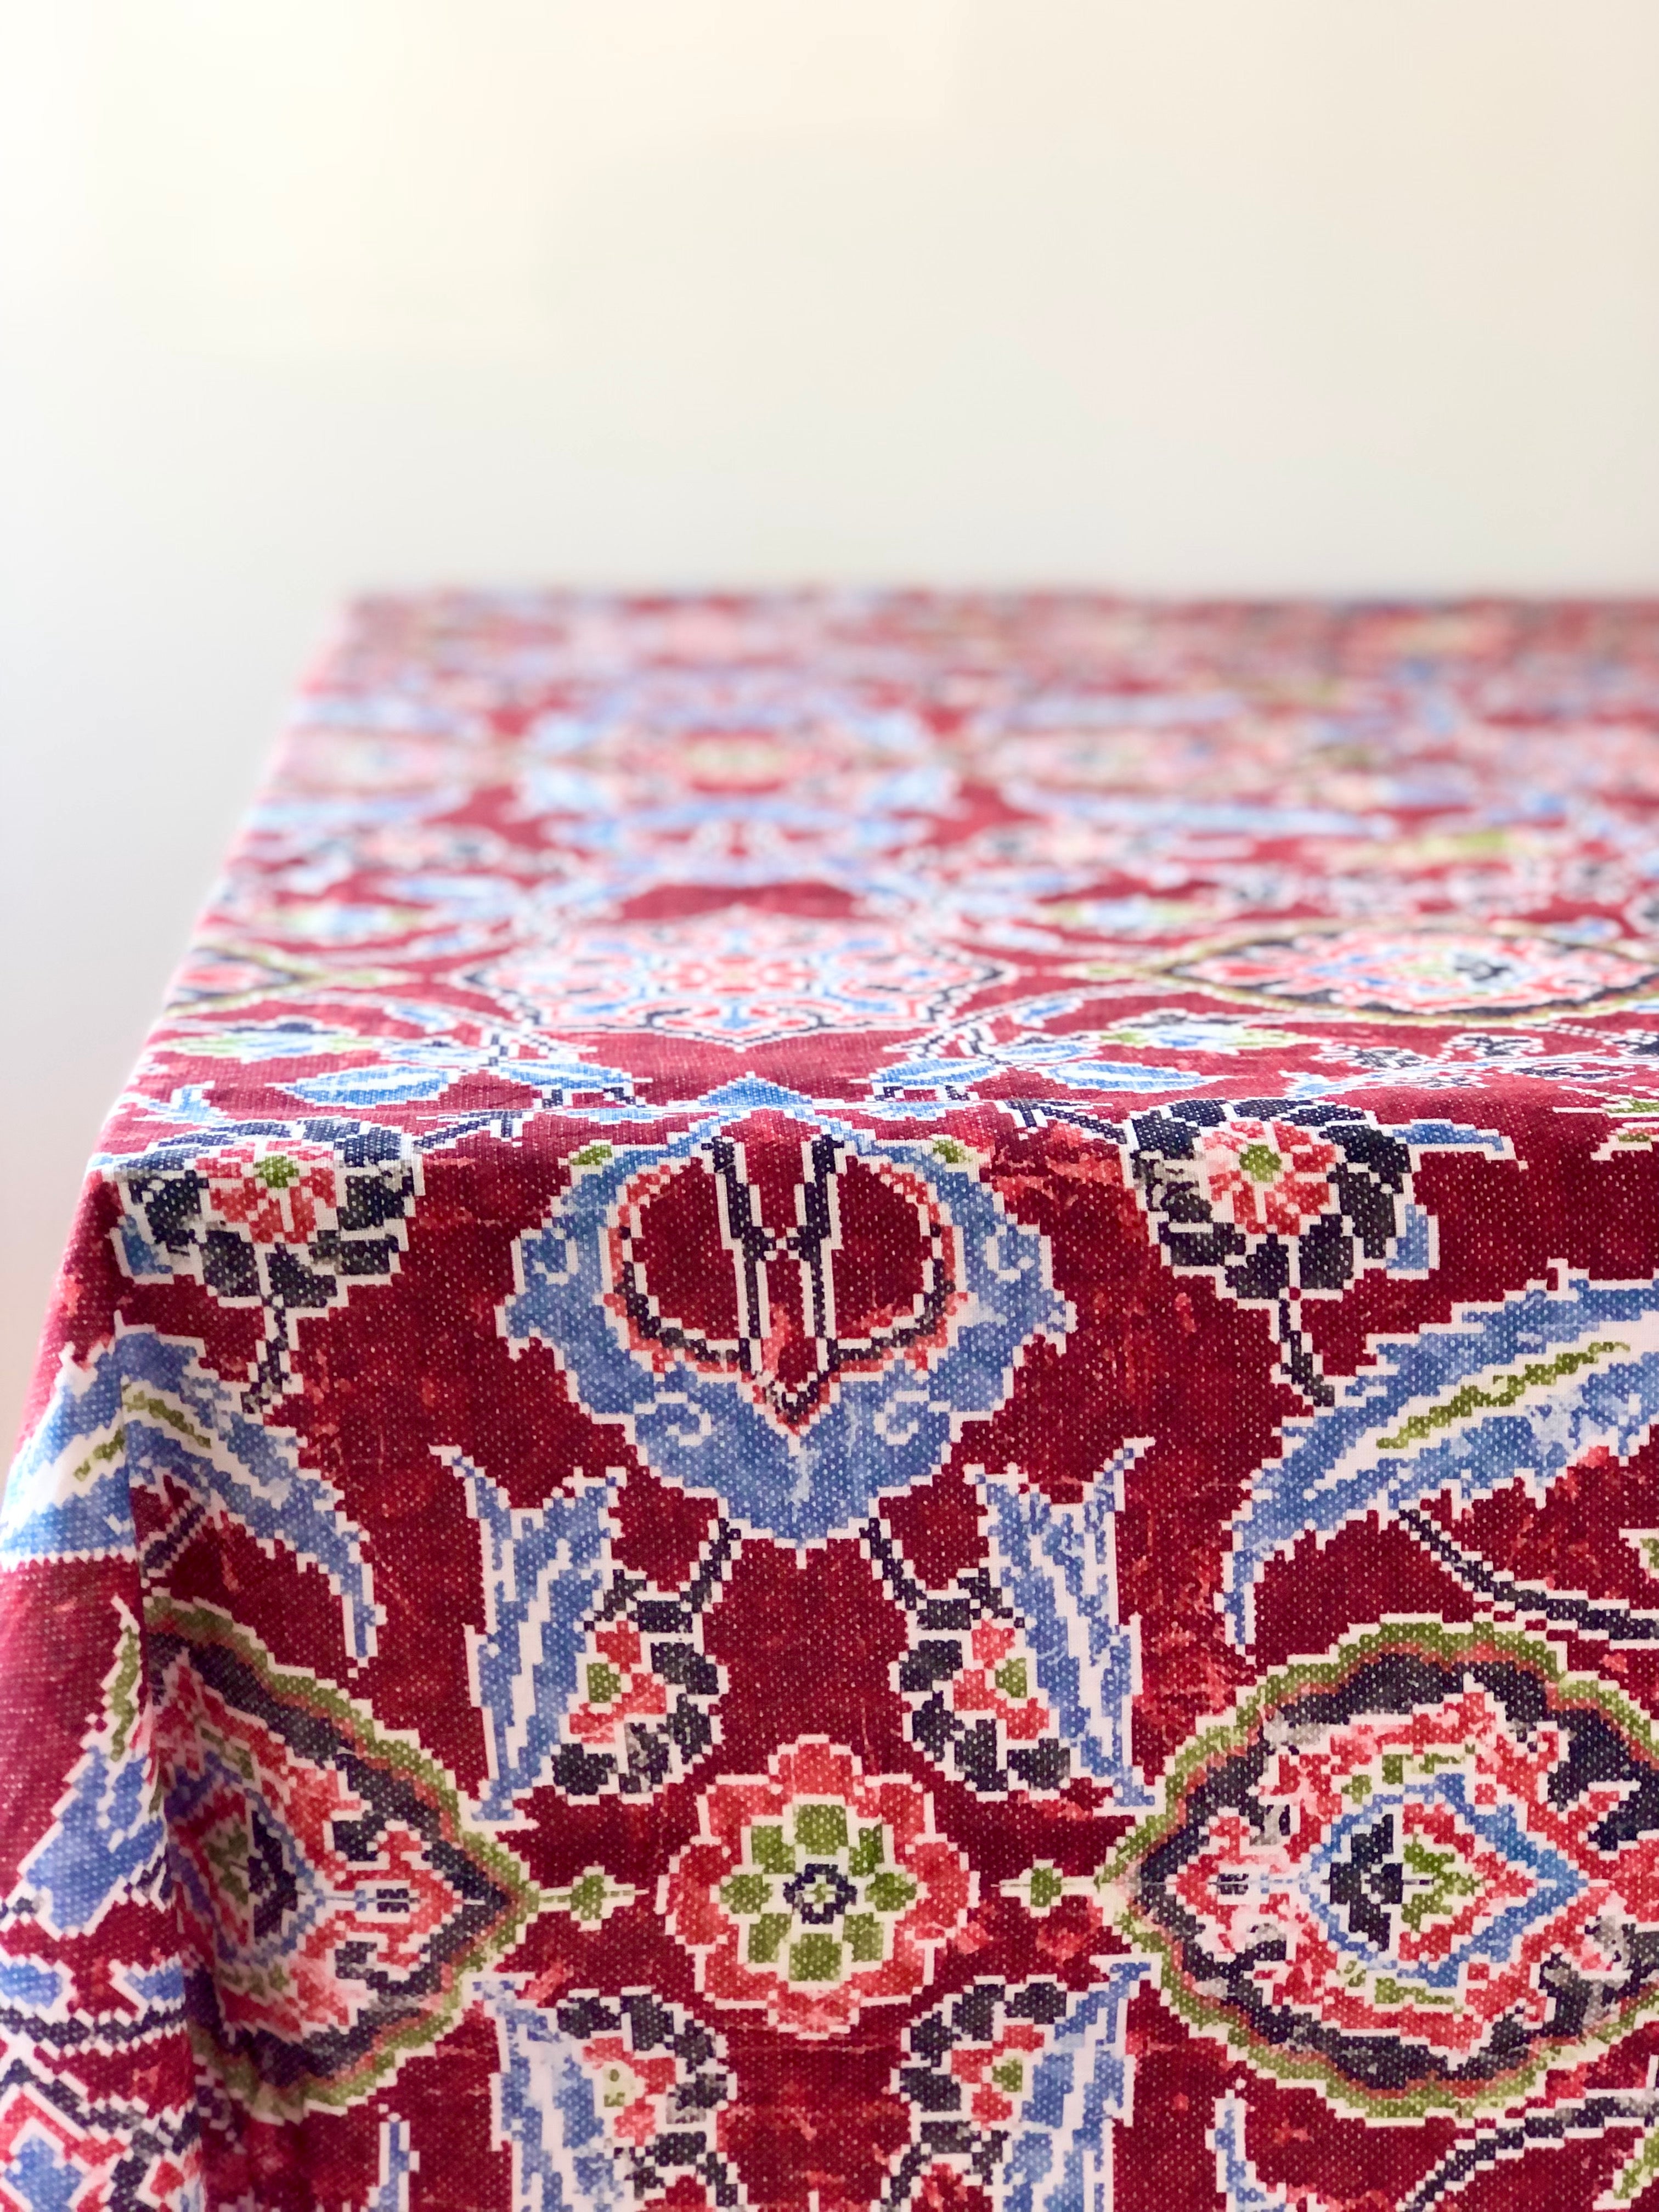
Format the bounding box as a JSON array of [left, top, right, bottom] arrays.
[[502, 1082, 1070, 1544]]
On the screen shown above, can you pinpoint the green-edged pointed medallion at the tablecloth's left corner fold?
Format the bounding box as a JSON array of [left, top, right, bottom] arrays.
[[146, 1601, 542, 2117]]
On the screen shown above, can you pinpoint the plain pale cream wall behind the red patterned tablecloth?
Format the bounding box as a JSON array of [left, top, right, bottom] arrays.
[[0, 0, 1659, 1431]]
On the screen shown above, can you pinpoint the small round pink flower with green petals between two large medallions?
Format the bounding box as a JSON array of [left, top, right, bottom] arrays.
[[664, 1736, 975, 2037]]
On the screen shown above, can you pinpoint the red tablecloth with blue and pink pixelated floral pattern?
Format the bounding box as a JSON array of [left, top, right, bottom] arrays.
[[0, 593, 1659, 2212]]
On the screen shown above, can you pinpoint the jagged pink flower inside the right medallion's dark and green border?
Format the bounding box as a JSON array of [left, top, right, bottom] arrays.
[[1175, 1688, 1657, 2057]]
